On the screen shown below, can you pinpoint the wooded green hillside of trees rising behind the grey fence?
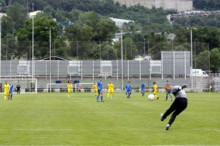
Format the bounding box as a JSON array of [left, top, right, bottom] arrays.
[[2, 0, 220, 70]]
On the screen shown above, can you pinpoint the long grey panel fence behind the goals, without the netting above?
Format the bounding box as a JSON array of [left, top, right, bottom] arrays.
[[1, 58, 213, 90]]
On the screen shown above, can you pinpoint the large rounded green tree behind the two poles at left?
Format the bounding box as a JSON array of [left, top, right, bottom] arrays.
[[17, 17, 59, 59]]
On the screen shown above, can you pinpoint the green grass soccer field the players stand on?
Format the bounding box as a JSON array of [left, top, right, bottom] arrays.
[[0, 93, 220, 146]]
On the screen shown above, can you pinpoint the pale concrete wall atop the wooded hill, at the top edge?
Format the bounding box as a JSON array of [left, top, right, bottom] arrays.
[[115, 0, 193, 11]]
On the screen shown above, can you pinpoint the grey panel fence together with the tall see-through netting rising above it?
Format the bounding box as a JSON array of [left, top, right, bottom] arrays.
[[0, 39, 213, 90]]
